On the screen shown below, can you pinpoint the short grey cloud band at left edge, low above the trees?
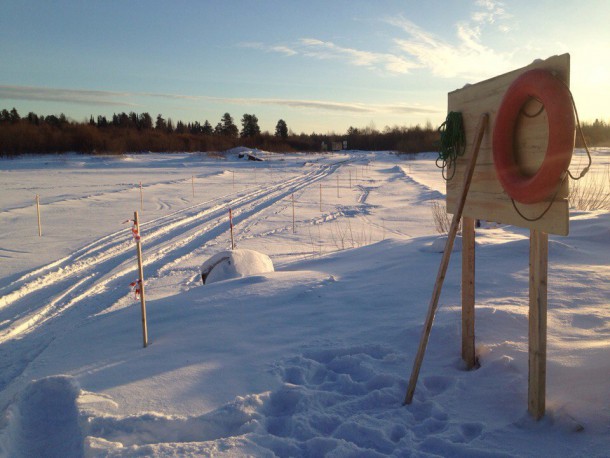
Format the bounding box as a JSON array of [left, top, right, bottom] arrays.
[[0, 85, 137, 107]]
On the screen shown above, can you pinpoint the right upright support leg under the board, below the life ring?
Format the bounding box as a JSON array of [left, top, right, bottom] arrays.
[[527, 229, 549, 420]]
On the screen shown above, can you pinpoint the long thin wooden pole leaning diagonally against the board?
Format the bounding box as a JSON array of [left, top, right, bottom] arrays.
[[404, 113, 489, 404]]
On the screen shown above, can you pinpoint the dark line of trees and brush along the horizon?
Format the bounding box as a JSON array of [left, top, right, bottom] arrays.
[[0, 108, 610, 156]]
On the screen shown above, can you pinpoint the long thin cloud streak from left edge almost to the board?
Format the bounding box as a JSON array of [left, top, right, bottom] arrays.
[[0, 85, 439, 114]]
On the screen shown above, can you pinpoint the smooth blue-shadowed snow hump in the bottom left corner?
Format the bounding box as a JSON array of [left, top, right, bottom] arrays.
[[0, 375, 83, 457]]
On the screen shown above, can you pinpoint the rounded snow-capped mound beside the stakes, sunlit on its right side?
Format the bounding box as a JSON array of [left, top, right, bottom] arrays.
[[201, 249, 274, 285]]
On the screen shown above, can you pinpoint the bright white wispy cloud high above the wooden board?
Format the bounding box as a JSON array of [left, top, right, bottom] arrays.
[[386, 0, 512, 78]]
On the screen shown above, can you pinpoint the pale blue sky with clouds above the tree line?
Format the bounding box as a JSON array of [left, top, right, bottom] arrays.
[[0, 0, 610, 133]]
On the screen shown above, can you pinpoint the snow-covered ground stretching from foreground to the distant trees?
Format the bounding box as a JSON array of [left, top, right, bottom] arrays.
[[0, 149, 610, 457]]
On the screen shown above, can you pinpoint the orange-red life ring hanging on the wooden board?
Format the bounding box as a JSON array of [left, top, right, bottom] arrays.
[[492, 70, 575, 204]]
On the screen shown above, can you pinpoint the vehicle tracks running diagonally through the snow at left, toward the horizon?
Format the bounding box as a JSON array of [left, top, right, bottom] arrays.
[[0, 160, 339, 342]]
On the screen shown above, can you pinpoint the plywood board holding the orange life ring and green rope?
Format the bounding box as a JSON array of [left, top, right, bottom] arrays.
[[447, 54, 570, 235]]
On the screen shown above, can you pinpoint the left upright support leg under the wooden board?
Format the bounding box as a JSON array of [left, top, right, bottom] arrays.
[[462, 217, 476, 369]]
